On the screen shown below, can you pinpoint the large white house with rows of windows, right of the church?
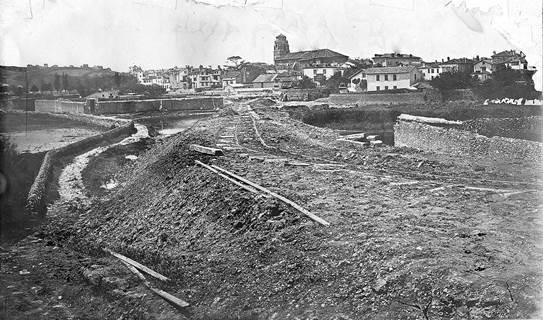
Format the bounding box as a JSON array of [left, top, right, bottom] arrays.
[[366, 65, 423, 91]]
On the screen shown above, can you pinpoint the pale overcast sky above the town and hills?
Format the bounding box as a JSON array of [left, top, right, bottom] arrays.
[[0, 0, 543, 88]]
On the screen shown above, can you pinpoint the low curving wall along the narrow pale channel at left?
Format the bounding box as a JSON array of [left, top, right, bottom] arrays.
[[26, 122, 136, 215]]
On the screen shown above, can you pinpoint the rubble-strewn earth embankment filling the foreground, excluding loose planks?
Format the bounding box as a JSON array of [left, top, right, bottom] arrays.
[[0, 100, 543, 319]]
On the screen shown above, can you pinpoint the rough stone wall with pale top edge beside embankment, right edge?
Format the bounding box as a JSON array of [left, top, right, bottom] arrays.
[[394, 120, 543, 162]]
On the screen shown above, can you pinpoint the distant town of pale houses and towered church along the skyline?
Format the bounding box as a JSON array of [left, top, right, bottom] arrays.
[[130, 34, 536, 92]]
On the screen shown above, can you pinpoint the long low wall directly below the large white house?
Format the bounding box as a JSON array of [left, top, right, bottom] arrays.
[[328, 90, 441, 106]]
